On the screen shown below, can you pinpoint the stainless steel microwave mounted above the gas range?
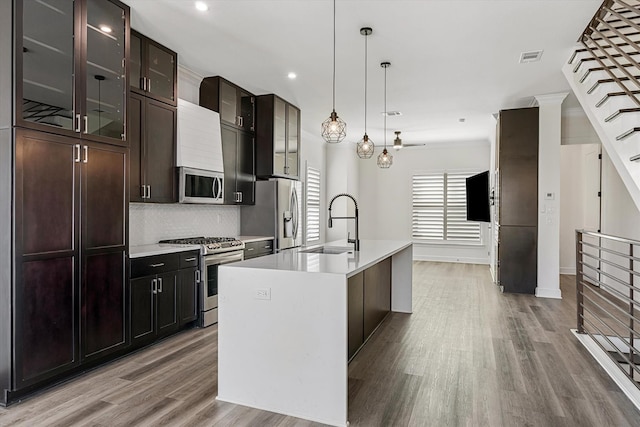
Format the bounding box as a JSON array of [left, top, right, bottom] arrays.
[[178, 167, 224, 204]]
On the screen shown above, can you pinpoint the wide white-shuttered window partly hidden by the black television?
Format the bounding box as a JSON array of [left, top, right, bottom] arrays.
[[412, 173, 481, 244]]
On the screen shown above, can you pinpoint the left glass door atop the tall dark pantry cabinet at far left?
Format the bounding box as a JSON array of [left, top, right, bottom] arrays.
[[21, 0, 77, 132]]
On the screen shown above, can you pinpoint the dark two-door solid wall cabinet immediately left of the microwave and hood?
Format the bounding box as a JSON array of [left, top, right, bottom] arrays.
[[128, 94, 178, 203]]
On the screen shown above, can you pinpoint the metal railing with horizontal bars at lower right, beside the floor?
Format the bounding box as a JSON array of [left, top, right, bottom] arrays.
[[576, 230, 640, 388]]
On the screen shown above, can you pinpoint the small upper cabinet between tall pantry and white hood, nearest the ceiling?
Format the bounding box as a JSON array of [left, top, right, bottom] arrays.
[[129, 30, 178, 107]]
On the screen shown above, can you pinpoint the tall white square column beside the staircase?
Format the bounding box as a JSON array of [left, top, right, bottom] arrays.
[[535, 92, 567, 299]]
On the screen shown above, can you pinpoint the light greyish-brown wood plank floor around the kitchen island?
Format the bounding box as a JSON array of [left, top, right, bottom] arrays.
[[0, 262, 640, 427]]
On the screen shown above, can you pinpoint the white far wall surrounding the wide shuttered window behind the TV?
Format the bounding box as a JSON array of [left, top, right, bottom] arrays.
[[360, 140, 491, 264]]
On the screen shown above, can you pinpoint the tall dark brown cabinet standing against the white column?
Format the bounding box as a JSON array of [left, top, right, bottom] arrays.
[[495, 108, 539, 294]]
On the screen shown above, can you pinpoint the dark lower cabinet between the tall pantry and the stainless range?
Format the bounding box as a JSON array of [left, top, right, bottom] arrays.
[[130, 251, 199, 346]]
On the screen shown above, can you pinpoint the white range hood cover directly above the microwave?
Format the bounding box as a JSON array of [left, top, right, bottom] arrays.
[[176, 99, 224, 172]]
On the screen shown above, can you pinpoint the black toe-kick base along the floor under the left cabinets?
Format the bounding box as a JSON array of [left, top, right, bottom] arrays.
[[0, 322, 196, 407]]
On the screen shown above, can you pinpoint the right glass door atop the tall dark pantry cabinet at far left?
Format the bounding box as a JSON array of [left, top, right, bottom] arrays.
[[83, 0, 127, 140]]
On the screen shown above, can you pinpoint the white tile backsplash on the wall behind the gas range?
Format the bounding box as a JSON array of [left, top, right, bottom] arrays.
[[129, 203, 240, 246]]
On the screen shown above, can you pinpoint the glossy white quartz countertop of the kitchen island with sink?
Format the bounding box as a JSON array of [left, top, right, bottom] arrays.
[[221, 240, 412, 277]]
